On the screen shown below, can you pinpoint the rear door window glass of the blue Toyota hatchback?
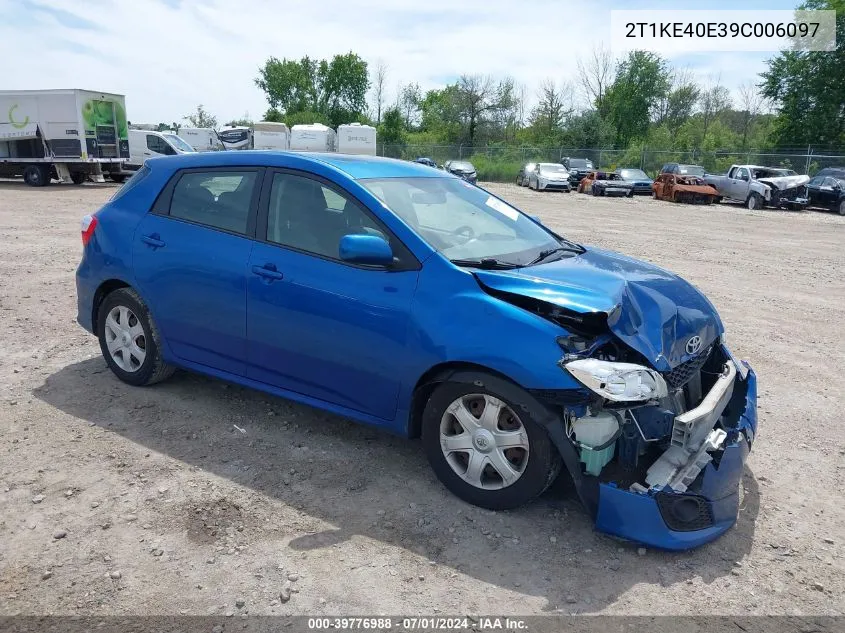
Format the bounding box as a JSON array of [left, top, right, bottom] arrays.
[[170, 171, 257, 235]]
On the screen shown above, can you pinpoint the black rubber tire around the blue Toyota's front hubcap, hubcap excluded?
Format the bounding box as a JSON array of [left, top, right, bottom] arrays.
[[422, 374, 562, 510]]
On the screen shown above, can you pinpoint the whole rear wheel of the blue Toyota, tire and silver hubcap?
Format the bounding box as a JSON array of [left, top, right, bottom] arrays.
[[97, 288, 175, 386]]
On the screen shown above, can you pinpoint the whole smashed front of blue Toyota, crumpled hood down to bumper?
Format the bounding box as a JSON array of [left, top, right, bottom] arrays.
[[478, 250, 757, 550]]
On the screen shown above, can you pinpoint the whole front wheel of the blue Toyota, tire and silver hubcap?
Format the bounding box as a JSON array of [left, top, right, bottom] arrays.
[[422, 382, 561, 510]]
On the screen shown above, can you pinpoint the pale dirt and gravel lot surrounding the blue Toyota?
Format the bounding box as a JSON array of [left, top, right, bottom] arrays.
[[0, 182, 845, 615]]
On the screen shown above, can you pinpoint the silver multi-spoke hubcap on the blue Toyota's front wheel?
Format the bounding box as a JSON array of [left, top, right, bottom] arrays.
[[440, 394, 528, 490]]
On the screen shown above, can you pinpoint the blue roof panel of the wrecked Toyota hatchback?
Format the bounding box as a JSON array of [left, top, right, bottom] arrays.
[[143, 150, 448, 180]]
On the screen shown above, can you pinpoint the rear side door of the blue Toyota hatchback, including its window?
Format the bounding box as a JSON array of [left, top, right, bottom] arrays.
[[133, 168, 263, 375]]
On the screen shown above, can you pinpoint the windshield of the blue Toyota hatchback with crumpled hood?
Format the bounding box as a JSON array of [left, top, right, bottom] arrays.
[[359, 178, 575, 266]]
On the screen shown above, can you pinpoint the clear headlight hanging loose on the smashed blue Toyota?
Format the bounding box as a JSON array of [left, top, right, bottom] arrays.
[[564, 358, 668, 402]]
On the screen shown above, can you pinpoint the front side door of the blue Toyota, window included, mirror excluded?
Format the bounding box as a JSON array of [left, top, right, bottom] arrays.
[[247, 170, 419, 420]]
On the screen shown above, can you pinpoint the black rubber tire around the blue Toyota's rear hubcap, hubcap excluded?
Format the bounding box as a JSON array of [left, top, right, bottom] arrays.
[[97, 288, 176, 387]]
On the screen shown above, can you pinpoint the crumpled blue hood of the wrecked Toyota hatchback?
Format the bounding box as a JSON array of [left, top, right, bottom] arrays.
[[474, 248, 723, 371]]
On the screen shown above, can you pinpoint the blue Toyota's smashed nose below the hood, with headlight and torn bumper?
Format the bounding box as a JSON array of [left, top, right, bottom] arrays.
[[560, 326, 757, 549]]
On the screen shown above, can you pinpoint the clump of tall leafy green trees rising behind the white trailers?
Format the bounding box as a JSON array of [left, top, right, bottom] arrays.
[[255, 52, 370, 127]]
